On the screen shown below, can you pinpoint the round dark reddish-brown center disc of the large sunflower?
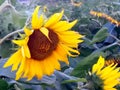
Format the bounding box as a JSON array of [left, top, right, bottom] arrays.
[[28, 30, 59, 60]]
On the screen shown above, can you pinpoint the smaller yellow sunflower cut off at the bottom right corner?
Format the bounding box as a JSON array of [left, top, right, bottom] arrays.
[[91, 56, 120, 90]]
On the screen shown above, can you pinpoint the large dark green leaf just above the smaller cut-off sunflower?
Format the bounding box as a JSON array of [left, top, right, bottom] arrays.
[[71, 51, 105, 78]]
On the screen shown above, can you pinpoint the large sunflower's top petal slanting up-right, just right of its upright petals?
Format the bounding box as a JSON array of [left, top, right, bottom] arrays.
[[44, 10, 64, 27]]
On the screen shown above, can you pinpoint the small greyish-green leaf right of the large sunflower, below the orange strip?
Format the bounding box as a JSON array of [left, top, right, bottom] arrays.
[[91, 28, 108, 44]]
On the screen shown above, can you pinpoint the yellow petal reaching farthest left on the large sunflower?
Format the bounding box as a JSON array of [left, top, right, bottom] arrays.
[[3, 49, 22, 68]]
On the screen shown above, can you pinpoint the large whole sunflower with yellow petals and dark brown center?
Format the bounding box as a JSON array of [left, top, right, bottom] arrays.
[[4, 6, 82, 80]]
